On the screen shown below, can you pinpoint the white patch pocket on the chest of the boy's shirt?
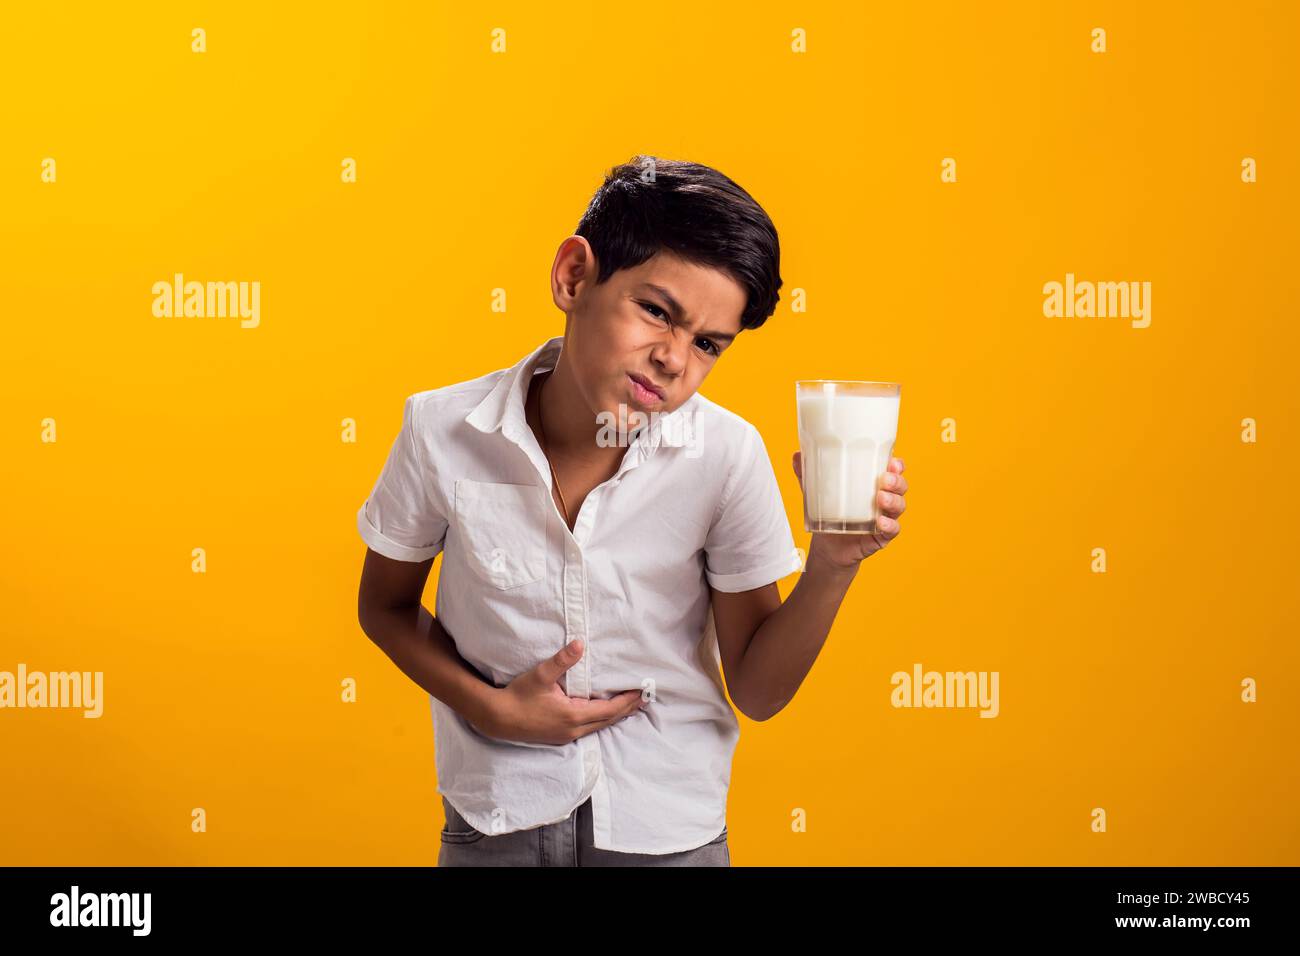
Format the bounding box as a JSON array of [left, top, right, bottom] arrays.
[[455, 479, 546, 591]]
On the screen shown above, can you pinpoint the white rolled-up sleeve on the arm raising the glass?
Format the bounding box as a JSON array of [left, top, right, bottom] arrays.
[[705, 425, 803, 592]]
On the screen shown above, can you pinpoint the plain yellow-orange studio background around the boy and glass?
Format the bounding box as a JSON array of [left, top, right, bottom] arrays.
[[0, 3, 1300, 865]]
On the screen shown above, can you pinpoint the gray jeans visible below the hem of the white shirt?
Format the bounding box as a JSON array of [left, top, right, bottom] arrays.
[[438, 797, 731, 866]]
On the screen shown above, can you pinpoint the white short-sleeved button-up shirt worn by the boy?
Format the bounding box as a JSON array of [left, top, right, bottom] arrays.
[[356, 337, 802, 853]]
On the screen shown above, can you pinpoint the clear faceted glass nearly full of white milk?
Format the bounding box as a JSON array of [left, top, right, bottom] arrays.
[[794, 380, 901, 535]]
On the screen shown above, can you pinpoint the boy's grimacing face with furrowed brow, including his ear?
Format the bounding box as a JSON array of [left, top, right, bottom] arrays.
[[551, 235, 746, 415]]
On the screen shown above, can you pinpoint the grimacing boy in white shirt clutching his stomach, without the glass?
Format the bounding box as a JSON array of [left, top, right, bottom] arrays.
[[358, 156, 906, 866]]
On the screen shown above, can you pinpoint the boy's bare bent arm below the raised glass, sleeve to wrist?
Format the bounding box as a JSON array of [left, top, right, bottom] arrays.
[[710, 554, 858, 721]]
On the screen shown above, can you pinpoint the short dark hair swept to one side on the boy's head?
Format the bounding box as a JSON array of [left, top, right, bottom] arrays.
[[576, 155, 781, 329]]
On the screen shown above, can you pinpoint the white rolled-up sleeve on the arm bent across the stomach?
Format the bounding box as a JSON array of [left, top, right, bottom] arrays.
[[356, 395, 447, 561]]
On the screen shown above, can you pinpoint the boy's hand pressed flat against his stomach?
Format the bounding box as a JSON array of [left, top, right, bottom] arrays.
[[476, 641, 644, 744]]
